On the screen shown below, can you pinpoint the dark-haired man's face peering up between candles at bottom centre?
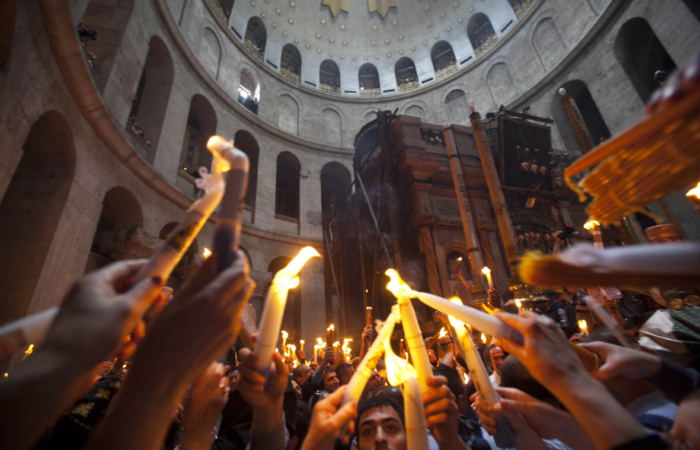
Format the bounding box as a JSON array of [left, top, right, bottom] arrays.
[[357, 406, 406, 450]]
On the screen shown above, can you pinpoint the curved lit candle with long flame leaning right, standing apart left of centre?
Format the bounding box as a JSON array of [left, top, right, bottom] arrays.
[[254, 247, 321, 382]]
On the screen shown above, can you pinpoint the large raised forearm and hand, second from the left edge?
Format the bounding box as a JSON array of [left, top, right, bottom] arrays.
[[86, 254, 255, 450]]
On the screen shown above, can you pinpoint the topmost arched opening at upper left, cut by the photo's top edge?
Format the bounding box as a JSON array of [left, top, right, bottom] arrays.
[[78, 0, 134, 92]]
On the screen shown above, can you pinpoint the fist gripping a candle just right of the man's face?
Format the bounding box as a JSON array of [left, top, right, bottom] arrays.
[[423, 376, 469, 450]]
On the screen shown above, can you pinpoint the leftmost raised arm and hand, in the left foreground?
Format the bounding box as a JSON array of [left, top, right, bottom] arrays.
[[0, 260, 162, 449]]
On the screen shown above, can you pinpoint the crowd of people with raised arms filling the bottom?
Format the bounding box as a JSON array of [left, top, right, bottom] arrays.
[[0, 246, 700, 450]]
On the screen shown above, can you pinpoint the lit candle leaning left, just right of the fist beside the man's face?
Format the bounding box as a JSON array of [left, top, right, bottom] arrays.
[[448, 298, 517, 448]]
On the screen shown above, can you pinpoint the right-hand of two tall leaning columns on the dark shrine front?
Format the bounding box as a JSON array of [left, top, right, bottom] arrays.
[[469, 104, 518, 280]]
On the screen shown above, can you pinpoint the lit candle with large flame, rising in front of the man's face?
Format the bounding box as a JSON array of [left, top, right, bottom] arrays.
[[384, 339, 430, 450]]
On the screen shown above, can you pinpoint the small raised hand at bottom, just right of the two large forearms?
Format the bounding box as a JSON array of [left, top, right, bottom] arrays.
[[182, 362, 229, 450]]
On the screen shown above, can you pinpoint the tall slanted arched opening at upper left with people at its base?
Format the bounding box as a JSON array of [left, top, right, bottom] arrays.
[[126, 36, 175, 163]]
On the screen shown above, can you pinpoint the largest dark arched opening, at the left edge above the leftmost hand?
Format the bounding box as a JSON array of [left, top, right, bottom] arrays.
[[0, 111, 75, 323]]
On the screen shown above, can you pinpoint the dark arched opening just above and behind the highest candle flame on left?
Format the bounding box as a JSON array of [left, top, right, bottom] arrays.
[[180, 94, 216, 178]]
